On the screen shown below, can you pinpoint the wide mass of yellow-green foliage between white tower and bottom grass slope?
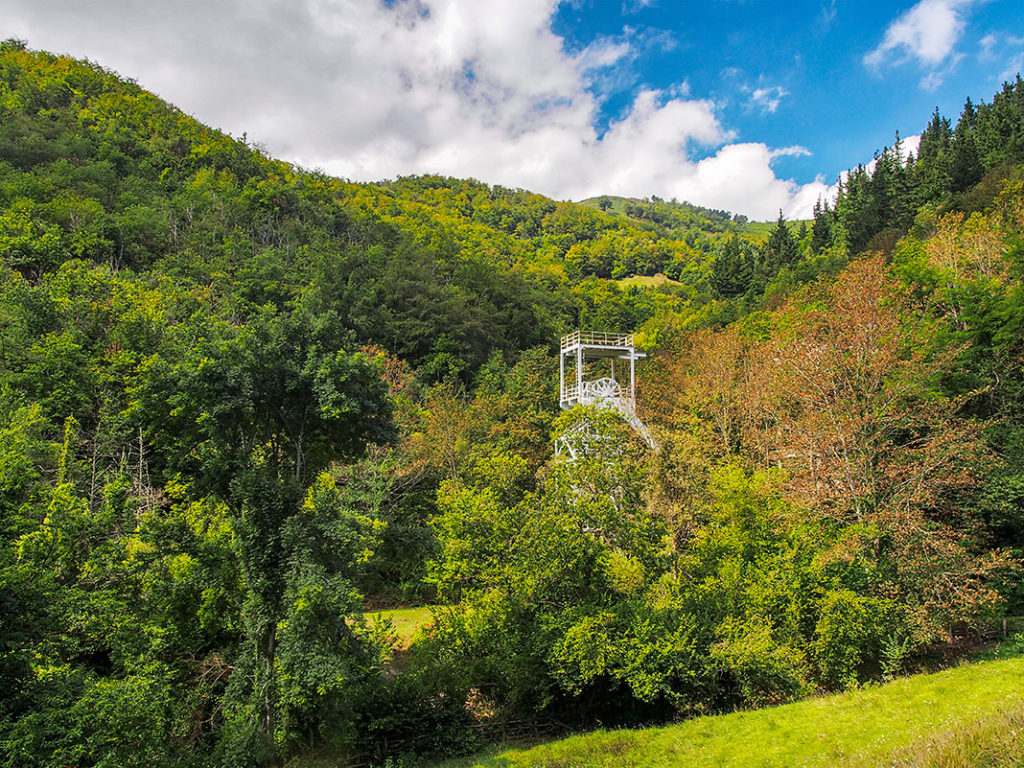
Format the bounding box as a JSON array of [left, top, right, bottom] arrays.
[[427, 438, 921, 722]]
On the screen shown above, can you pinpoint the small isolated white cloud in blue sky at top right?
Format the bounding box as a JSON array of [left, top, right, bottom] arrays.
[[864, 0, 977, 68]]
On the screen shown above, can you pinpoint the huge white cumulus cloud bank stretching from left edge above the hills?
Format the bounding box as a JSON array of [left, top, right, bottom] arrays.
[[0, 0, 827, 218]]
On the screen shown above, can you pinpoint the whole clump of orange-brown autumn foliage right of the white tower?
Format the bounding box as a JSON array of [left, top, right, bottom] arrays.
[[662, 256, 1010, 643]]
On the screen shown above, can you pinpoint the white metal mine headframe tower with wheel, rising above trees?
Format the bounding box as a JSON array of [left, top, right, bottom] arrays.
[[558, 331, 655, 458]]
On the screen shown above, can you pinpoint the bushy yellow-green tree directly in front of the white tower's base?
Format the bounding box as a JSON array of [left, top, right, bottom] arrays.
[[429, 409, 671, 717]]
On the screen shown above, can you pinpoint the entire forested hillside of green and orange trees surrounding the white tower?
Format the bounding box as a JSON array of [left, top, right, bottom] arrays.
[[6, 40, 1024, 766]]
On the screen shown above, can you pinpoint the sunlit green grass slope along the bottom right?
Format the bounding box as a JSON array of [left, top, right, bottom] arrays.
[[442, 657, 1024, 768]]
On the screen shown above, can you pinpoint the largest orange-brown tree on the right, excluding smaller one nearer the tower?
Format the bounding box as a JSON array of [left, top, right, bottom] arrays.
[[743, 257, 1006, 643]]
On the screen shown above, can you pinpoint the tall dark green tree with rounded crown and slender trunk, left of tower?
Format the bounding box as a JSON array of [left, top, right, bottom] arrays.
[[141, 308, 392, 760]]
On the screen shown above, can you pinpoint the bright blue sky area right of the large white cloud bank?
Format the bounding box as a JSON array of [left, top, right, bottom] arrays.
[[553, 0, 1024, 182]]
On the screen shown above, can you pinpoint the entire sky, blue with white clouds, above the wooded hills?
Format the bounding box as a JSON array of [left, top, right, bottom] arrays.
[[0, 0, 1024, 220]]
